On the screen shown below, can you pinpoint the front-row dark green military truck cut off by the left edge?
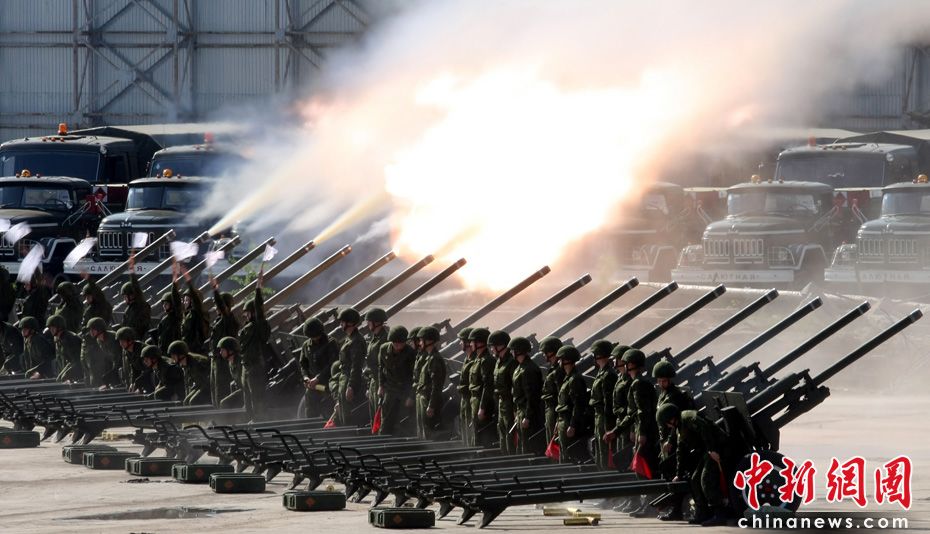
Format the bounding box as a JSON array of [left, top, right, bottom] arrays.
[[0, 175, 105, 275]]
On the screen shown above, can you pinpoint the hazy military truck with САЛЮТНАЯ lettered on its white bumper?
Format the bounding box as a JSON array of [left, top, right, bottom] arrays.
[[672, 176, 843, 286]]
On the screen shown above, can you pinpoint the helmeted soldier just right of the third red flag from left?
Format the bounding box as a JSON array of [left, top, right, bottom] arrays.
[[555, 345, 591, 462]]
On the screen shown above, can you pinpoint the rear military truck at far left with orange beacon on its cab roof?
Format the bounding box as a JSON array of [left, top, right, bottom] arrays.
[[0, 124, 161, 212]]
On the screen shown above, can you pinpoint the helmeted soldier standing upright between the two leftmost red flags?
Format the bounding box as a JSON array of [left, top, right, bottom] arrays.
[[336, 308, 367, 426]]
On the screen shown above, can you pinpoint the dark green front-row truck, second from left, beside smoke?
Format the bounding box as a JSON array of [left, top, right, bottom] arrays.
[[69, 176, 216, 275]]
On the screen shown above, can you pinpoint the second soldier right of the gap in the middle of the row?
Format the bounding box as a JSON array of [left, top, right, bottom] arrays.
[[468, 328, 497, 447]]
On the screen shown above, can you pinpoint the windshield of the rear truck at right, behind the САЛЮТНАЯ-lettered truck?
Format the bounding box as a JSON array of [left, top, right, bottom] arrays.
[[775, 152, 885, 187]]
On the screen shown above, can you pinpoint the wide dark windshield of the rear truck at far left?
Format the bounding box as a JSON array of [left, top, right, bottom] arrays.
[[0, 149, 100, 183]]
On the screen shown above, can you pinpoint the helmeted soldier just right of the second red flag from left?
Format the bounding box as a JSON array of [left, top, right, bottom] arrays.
[[378, 326, 417, 435]]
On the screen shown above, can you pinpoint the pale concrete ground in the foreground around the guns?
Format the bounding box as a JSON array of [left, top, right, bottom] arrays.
[[0, 392, 930, 534]]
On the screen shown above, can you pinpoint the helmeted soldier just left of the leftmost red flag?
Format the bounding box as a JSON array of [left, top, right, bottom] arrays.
[[300, 318, 339, 417]]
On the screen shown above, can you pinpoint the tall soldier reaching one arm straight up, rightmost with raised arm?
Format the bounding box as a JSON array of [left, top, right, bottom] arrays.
[[239, 269, 271, 421]]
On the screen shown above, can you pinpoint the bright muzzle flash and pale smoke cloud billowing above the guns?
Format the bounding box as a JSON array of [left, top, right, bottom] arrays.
[[203, 0, 930, 289]]
